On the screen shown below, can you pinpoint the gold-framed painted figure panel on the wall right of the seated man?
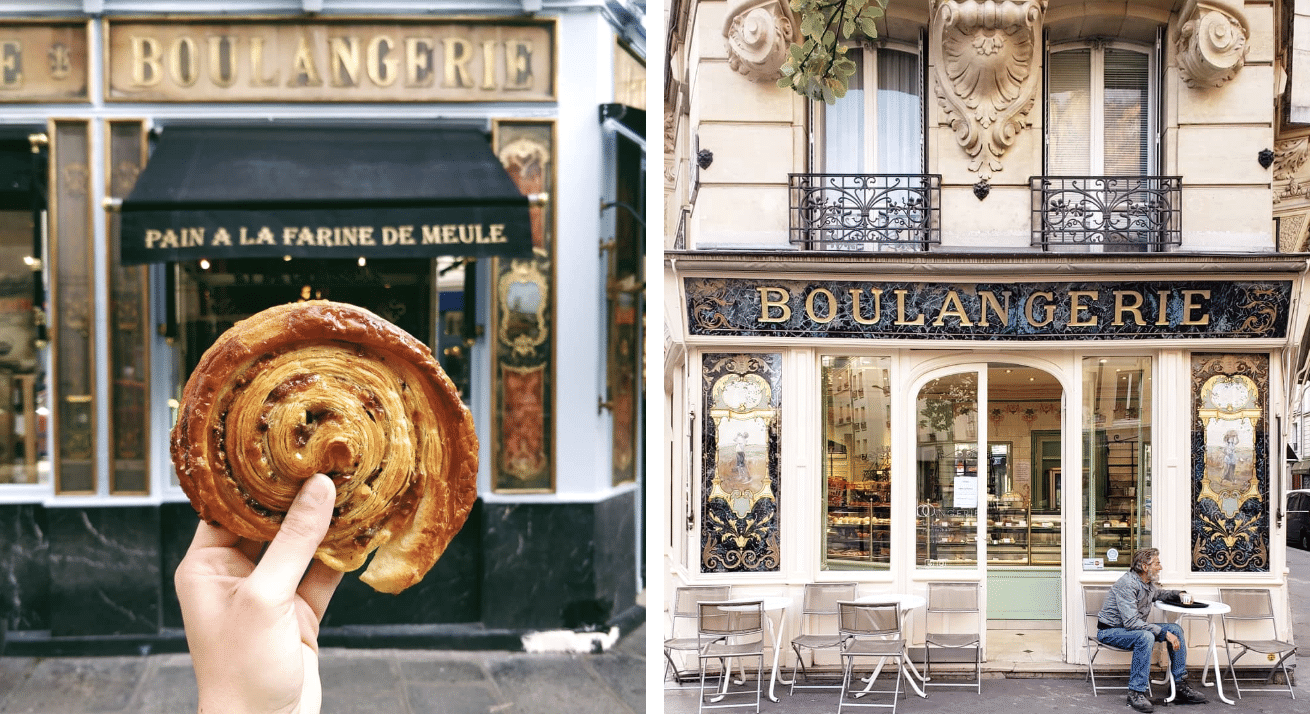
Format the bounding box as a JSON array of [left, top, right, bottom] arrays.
[[1192, 354, 1269, 573]]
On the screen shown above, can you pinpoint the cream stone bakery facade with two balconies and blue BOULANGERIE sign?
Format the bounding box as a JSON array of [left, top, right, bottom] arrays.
[[664, 0, 1306, 663]]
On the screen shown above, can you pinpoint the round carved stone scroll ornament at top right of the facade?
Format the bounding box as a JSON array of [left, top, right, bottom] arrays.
[[1174, 0, 1251, 88]]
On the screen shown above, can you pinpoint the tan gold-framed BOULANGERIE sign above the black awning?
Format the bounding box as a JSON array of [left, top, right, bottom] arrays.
[[105, 18, 555, 102]]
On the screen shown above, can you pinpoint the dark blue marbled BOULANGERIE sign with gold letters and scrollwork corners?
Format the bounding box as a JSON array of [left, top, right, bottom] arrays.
[[685, 278, 1292, 341]]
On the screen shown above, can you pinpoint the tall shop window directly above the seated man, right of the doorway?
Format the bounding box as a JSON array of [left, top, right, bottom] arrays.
[[1082, 356, 1153, 569]]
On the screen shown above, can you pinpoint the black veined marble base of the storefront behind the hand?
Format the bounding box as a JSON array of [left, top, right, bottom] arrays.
[[0, 493, 643, 656]]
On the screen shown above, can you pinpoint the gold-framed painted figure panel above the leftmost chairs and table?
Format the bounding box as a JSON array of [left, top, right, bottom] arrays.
[[701, 354, 782, 573]]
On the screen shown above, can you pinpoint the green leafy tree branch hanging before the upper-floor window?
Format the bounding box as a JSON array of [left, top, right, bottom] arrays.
[[778, 0, 888, 103]]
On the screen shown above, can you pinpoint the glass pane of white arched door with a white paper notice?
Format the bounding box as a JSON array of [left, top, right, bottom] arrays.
[[914, 372, 986, 567]]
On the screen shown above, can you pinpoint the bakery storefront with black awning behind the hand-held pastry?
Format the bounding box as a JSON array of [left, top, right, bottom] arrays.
[[0, 12, 641, 654]]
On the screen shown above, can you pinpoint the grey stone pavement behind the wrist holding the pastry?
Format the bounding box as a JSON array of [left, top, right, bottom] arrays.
[[0, 625, 646, 714]]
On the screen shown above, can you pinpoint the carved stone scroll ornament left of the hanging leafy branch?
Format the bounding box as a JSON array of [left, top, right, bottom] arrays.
[[723, 0, 799, 83]]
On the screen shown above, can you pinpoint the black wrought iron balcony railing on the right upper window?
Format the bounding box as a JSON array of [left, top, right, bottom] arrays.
[[1028, 176, 1183, 253]]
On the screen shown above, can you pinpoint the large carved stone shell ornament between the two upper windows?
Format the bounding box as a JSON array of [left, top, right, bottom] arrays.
[[929, 0, 1047, 178]]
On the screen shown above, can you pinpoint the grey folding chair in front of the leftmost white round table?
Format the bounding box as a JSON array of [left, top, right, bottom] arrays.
[[697, 600, 764, 714]]
